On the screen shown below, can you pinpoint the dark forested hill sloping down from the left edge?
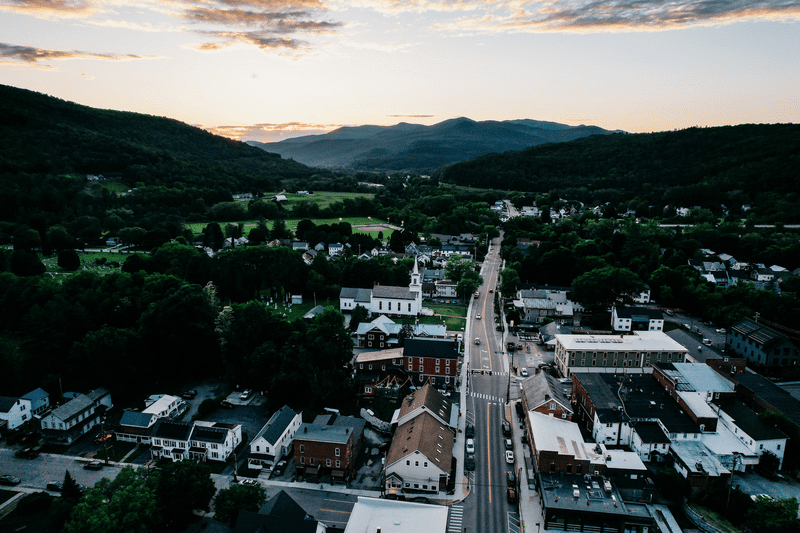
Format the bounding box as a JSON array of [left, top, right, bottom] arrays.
[[0, 85, 312, 195]]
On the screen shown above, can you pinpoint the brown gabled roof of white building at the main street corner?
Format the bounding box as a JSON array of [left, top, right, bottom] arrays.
[[386, 413, 455, 473]]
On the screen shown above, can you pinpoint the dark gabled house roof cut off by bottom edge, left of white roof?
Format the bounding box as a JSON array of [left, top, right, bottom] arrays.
[[233, 490, 327, 533]]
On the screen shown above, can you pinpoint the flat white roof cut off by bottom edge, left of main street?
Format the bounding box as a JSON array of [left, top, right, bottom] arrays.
[[344, 496, 448, 533]]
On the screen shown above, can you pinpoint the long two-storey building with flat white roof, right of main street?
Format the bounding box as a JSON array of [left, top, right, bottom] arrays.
[[555, 331, 688, 377]]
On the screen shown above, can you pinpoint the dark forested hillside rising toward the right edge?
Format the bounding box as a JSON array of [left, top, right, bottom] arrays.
[[438, 124, 800, 223]]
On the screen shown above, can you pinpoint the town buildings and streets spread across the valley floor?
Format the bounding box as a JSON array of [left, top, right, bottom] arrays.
[[0, 193, 800, 533]]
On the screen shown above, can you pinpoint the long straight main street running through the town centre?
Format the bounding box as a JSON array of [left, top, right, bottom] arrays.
[[462, 239, 519, 533]]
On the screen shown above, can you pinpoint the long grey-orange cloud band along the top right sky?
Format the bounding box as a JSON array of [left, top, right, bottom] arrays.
[[434, 0, 800, 33]]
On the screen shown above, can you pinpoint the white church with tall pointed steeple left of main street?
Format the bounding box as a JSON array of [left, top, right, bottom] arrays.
[[339, 260, 422, 316]]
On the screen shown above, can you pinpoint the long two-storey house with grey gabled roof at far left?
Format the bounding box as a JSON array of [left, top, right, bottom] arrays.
[[42, 387, 114, 444]]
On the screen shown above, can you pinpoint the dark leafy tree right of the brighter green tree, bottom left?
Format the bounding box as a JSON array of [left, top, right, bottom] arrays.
[[158, 460, 217, 527]]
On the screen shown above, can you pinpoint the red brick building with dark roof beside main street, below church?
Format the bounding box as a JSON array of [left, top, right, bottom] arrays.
[[403, 339, 459, 389]]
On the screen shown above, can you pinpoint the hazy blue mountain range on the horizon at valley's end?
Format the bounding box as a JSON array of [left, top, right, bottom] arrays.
[[248, 118, 612, 172]]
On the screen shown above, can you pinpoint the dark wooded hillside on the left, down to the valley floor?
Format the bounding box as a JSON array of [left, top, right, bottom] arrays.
[[0, 82, 313, 221]]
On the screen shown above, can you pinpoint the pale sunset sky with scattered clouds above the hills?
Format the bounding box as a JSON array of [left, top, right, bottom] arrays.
[[0, 0, 800, 142]]
